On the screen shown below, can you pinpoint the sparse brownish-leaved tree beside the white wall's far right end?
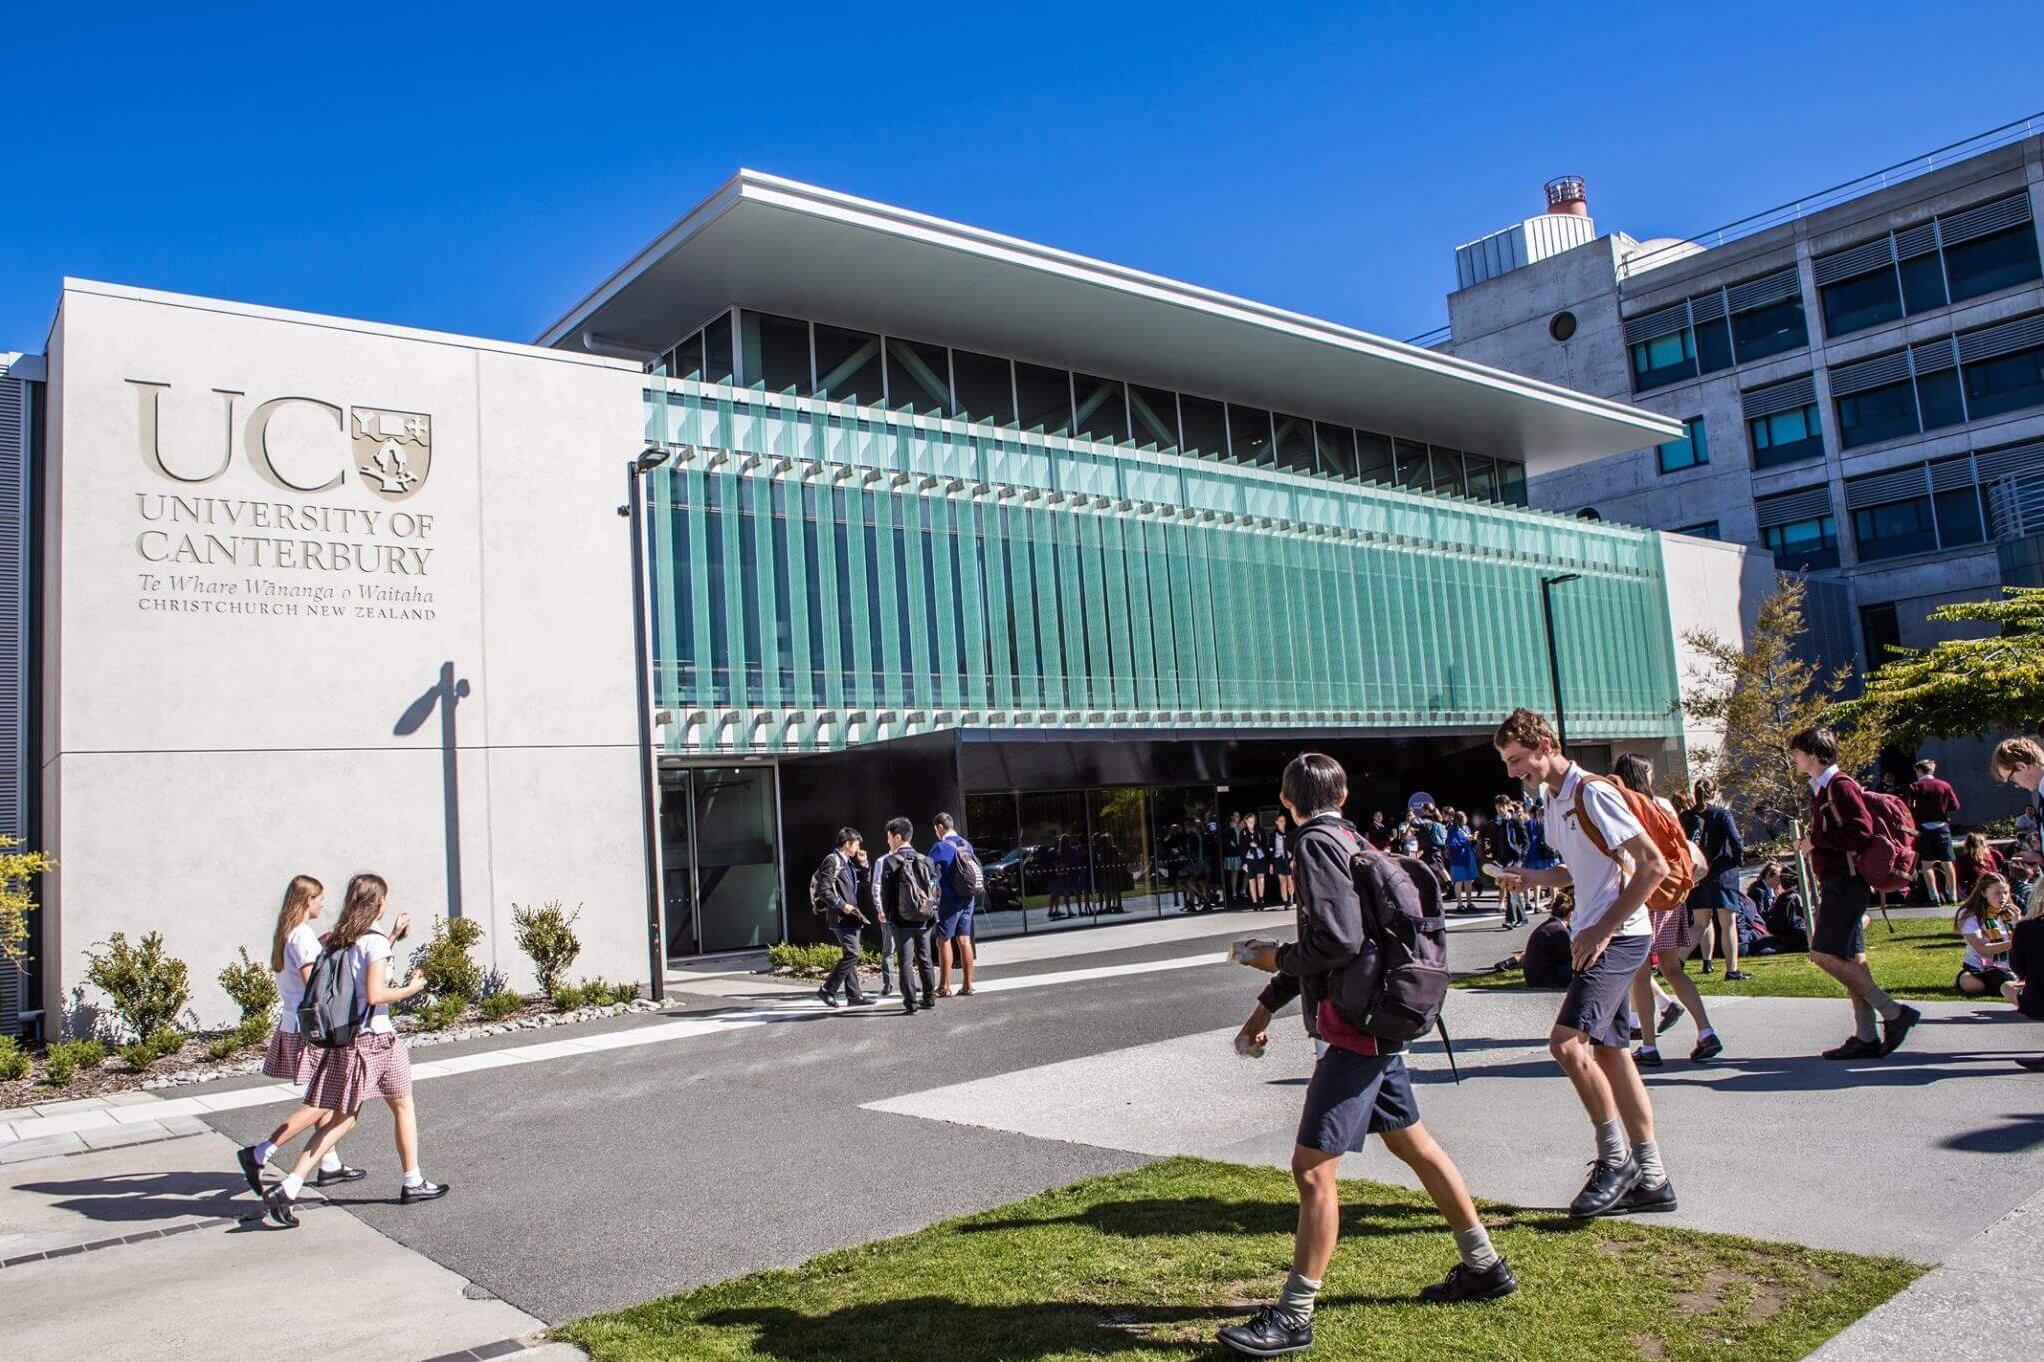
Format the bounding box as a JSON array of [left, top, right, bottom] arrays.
[[1682, 573, 1883, 822]]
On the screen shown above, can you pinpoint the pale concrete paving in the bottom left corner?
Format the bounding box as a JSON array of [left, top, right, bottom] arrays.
[[0, 1131, 580, 1362]]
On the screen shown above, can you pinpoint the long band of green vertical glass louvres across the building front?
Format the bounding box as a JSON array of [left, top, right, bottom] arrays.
[[648, 380, 1676, 753]]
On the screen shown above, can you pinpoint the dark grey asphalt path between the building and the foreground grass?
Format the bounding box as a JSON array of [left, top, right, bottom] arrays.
[[211, 912, 1523, 1323]]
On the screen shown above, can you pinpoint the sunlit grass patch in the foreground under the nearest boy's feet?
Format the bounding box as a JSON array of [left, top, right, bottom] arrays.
[[554, 1157, 1923, 1362]]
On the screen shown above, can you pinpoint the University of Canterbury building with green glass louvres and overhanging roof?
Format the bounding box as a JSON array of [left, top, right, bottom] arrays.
[[0, 172, 1768, 1020]]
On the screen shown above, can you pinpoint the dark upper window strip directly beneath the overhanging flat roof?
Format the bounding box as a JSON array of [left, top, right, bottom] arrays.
[[658, 309, 1525, 505]]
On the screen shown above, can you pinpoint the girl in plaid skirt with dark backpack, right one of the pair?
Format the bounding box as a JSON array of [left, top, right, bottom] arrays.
[[264, 873, 448, 1229]]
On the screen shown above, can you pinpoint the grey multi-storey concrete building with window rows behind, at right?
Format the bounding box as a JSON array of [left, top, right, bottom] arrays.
[[1437, 119, 2044, 816]]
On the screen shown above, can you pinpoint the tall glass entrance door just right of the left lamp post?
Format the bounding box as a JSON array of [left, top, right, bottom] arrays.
[[660, 767, 783, 959]]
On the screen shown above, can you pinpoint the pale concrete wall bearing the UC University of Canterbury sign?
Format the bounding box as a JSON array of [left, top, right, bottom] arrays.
[[41, 280, 648, 1023]]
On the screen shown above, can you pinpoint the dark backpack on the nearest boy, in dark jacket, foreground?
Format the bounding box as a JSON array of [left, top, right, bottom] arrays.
[[1329, 824, 1449, 1041]]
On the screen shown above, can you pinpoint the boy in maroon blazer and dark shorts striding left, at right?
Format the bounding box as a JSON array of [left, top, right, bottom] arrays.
[[1789, 724, 1923, 1059]]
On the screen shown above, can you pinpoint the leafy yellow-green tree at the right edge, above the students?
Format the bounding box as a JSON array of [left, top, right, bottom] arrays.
[[1838, 587, 2044, 746]]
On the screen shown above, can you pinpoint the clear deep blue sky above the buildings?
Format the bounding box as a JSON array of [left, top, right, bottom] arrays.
[[0, 2, 2044, 350]]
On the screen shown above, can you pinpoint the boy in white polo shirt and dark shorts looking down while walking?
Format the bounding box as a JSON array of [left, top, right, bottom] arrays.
[[1490, 710, 1676, 1217]]
